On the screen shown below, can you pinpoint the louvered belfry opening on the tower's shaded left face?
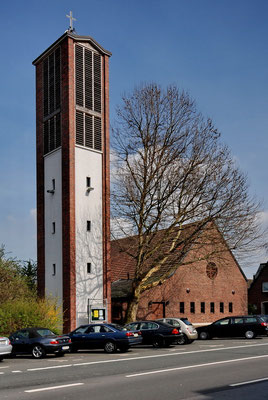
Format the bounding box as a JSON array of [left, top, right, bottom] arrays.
[[43, 47, 61, 154]]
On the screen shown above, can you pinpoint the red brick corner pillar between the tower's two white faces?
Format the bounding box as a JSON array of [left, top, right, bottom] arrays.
[[61, 37, 76, 332]]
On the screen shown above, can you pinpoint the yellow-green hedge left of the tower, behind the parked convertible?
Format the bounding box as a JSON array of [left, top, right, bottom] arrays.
[[0, 298, 63, 336]]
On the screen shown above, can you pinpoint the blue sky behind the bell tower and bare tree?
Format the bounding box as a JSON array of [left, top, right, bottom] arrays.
[[0, 0, 268, 277]]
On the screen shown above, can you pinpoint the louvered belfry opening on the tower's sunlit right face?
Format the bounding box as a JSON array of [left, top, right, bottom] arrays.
[[75, 45, 102, 151]]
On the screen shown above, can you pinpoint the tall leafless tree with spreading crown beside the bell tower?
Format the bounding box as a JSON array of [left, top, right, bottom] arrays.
[[112, 84, 260, 320]]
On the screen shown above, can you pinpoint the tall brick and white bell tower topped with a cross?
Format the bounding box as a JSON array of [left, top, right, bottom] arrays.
[[33, 15, 111, 332]]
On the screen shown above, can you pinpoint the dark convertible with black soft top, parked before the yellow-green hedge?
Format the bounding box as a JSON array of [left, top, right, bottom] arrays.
[[9, 328, 71, 358]]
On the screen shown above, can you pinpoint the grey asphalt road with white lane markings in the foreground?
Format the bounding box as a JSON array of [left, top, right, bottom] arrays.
[[0, 338, 268, 400]]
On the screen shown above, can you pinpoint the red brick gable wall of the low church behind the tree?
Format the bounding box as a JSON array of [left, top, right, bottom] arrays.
[[138, 247, 247, 323]]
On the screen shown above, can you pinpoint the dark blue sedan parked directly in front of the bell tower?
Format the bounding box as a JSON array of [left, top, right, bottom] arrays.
[[69, 323, 142, 353]]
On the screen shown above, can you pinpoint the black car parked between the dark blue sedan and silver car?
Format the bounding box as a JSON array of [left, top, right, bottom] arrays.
[[125, 321, 182, 347]]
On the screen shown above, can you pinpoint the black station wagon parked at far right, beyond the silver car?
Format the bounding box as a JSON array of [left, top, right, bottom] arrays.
[[197, 315, 268, 339]]
